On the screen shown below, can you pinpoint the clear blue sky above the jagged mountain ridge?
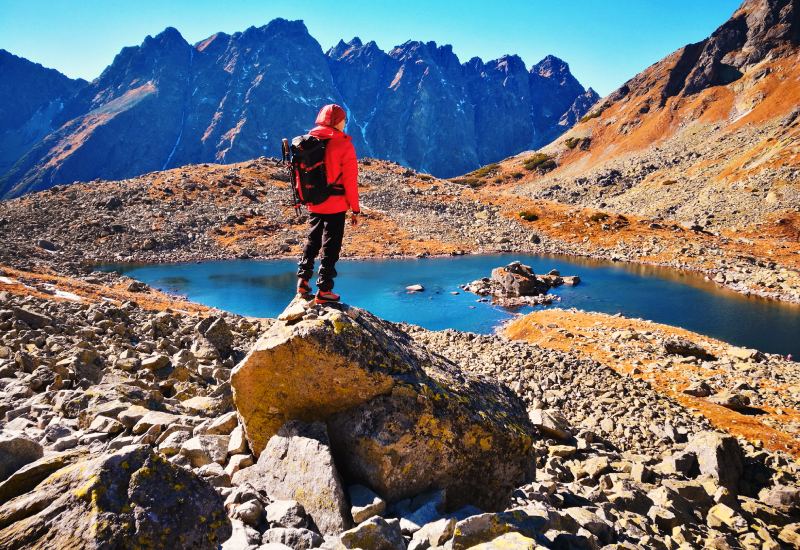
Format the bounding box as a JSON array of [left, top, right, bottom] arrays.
[[0, 0, 740, 95]]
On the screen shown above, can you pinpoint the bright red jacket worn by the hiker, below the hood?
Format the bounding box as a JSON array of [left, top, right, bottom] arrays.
[[308, 126, 361, 214]]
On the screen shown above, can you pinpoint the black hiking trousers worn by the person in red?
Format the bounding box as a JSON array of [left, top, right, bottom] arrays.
[[297, 212, 345, 292]]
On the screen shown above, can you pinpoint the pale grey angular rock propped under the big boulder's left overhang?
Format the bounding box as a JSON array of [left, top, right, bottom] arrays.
[[228, 420, 352, 535]]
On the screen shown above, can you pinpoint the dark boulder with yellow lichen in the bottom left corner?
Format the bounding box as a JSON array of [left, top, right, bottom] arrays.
[[0, 445, 231, 550]]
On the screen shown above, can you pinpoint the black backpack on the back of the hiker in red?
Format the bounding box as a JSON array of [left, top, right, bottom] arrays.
[[290, 134, 344, 206]]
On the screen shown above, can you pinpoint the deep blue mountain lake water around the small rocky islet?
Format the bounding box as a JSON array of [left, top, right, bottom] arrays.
[[105, 255, 800, 358]]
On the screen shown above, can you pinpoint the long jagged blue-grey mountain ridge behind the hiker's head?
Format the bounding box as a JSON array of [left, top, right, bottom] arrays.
[[0, 19, 598, 197]]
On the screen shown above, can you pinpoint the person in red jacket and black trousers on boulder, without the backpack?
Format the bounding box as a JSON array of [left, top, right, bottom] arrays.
[[297, 104, 361, 304]]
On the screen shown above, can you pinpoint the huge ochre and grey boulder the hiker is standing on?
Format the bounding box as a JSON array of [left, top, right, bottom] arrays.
[[231, 306, 534, 510]]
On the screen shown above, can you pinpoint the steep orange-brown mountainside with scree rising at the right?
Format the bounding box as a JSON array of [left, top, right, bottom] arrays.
[[502, 0, 800, 228]]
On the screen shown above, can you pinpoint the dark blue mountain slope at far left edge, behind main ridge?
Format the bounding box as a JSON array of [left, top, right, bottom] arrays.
[[0, 49, 86, 185]]
